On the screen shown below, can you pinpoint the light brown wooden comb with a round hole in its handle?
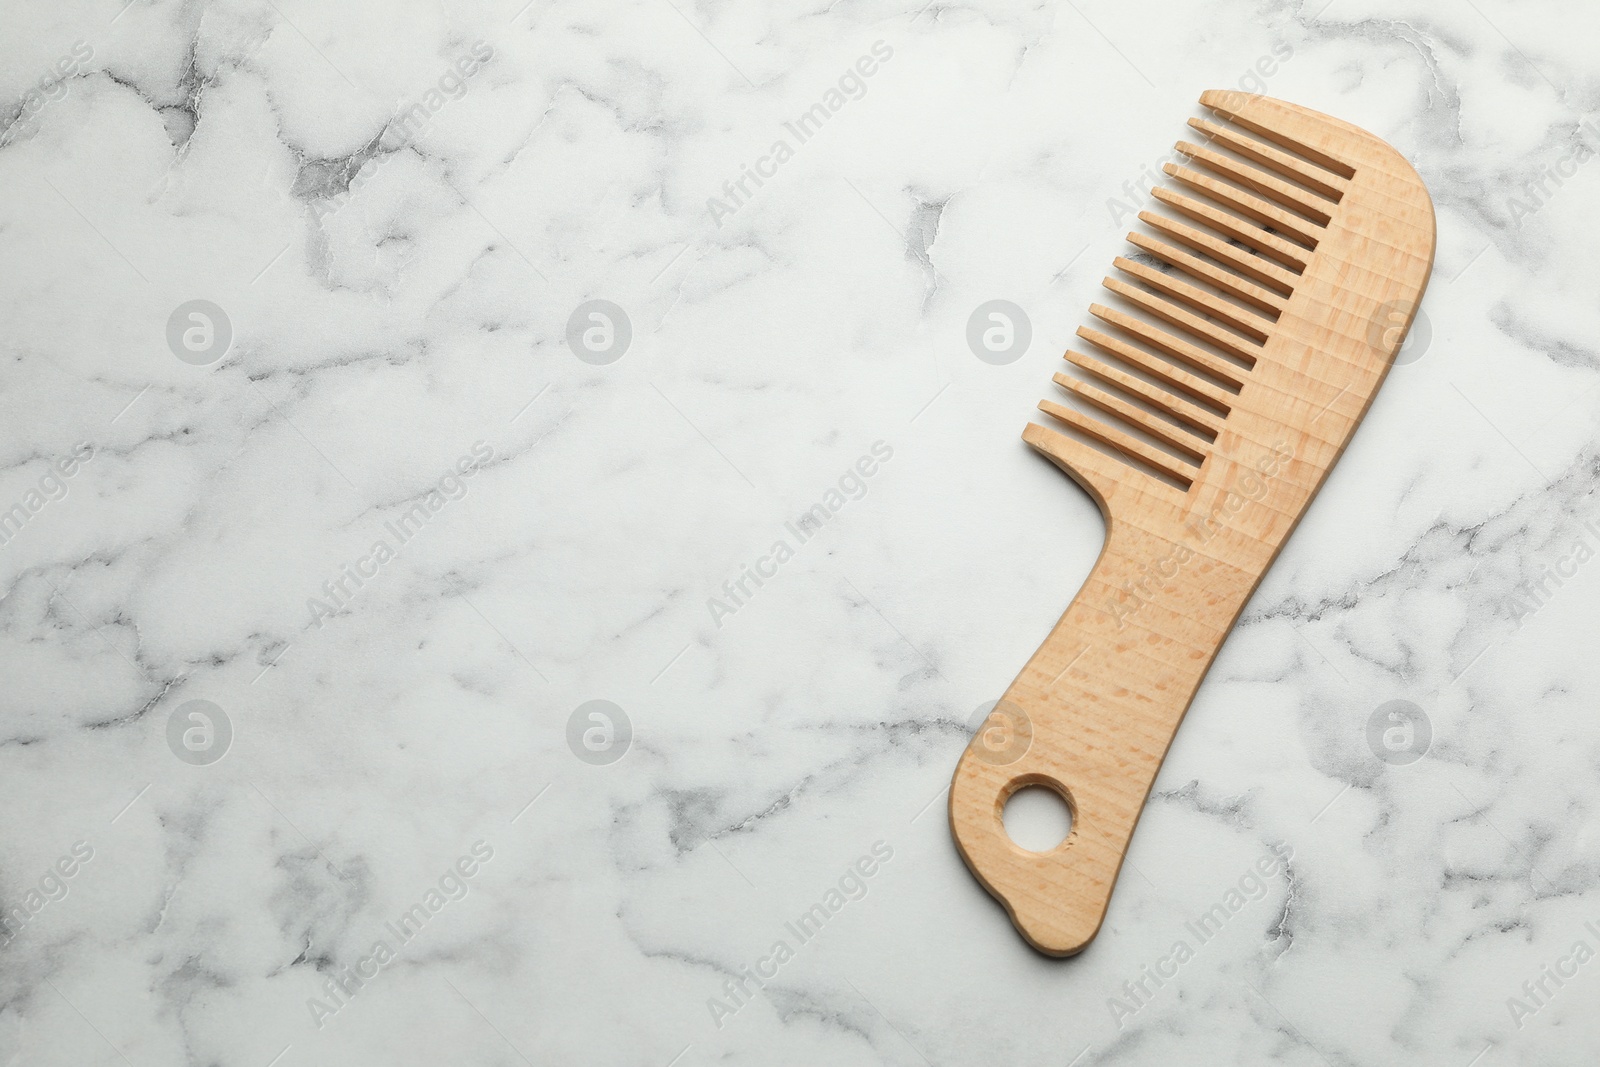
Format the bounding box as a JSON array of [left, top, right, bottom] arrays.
[[950, 91, 1434, 955]]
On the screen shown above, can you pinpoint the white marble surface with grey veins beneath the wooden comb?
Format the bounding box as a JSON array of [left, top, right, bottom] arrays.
[[0, 0, 1600, 1067]]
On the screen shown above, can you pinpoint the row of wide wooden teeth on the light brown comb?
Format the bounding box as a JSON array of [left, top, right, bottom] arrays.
[[1030, 93, 1401, 502]]
